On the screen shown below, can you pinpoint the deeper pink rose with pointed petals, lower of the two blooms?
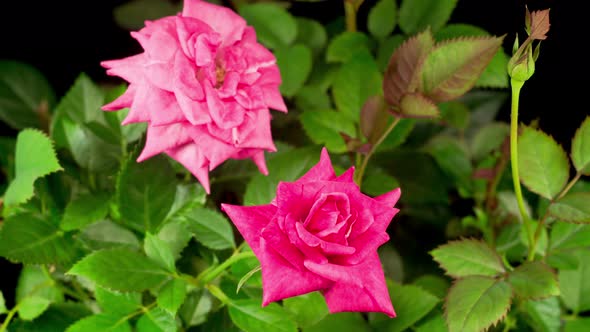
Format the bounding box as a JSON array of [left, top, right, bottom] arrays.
[[222, 148, 401, 317]]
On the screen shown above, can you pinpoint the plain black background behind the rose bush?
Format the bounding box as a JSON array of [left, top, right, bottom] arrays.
[[0, 0, 590, 305]]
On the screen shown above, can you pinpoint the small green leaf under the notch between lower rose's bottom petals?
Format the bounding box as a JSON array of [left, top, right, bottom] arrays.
[[283, 292, 329, 328]]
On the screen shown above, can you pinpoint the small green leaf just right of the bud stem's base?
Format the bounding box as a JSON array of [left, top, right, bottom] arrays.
[[508, 261, 559, 300]]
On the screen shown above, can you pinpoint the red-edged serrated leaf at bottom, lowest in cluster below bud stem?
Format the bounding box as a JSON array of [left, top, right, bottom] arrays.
[[445, 276, 512, 332]]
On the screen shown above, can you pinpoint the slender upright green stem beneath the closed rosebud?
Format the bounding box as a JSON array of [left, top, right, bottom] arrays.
[[510, 79, 535, 261]]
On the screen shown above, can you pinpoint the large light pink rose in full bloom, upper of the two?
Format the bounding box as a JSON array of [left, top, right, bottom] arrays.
[[102, 0, 287, 192]]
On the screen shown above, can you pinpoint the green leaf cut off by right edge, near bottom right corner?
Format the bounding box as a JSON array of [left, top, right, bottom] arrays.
[[559, 249, 590, 313]]
